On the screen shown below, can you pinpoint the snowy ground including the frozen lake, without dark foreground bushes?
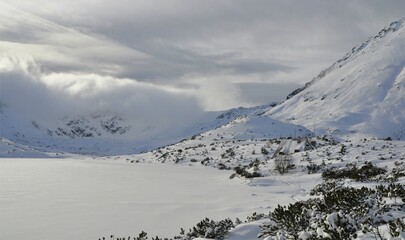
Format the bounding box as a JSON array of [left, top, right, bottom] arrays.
[[0, 134, 405, 240]]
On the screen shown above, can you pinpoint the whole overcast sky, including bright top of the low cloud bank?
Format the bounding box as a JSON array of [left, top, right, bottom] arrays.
[[0, 0, 405, 117]]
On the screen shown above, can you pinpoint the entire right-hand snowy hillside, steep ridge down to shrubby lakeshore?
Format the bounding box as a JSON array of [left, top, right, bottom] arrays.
[[95, 19, 405, 240]]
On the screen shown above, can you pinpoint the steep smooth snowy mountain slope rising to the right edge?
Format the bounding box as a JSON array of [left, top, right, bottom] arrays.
[[267, 18, 405, 139]]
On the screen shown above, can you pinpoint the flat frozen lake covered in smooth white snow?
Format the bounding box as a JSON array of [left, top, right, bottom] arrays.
[[0, 158, 285, 240]]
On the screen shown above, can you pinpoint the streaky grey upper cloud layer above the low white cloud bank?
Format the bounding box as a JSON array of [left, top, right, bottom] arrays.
[[0, 0, 405, 109]]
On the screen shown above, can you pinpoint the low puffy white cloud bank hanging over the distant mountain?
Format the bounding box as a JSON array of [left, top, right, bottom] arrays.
[[0, 56, 203, 128]]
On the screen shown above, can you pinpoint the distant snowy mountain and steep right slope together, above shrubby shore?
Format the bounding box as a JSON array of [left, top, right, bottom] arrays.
[[0, 15, 405, 155]]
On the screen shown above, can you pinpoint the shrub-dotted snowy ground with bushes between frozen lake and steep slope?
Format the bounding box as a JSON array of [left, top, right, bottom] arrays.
[[109, 134, 405, 240]]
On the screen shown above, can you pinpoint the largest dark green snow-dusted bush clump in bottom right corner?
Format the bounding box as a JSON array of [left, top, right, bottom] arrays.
[[259, 182, 405, 239]]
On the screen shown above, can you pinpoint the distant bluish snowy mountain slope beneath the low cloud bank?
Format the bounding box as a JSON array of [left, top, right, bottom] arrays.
[[0, 100, 275, 155]]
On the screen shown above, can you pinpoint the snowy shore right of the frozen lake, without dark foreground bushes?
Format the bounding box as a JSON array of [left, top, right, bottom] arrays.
[[116, 132, 405, 240]]
